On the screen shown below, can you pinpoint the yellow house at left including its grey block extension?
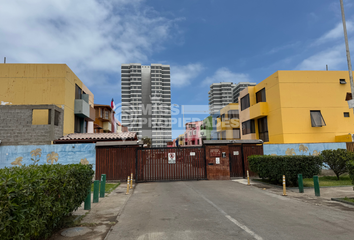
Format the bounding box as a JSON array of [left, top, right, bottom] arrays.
[[0, 63, 95, 145]]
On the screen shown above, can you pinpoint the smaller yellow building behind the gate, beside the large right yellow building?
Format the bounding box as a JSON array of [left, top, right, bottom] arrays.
[[216, 103, 241, 140]]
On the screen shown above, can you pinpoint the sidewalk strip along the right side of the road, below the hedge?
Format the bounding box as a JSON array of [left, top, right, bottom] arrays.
[[232, 178, 354, 211]]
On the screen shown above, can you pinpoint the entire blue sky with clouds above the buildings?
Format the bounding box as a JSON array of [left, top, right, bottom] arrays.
[[0, 0, 354, 138]]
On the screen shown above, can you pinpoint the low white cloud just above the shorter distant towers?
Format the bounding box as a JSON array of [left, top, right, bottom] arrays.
[[203, 67, 251, 85]]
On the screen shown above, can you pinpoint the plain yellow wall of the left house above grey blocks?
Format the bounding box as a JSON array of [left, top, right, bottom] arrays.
[[0, 63, 94, 135]]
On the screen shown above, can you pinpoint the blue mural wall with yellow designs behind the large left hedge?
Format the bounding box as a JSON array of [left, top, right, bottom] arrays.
[[0, 143, 96, 170]]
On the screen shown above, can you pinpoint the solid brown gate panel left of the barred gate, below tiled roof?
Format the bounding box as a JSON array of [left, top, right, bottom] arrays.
[[96, 146, 138, 181]]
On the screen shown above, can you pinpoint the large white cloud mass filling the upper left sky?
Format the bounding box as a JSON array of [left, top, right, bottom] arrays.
[[0, 0, 180, 96]]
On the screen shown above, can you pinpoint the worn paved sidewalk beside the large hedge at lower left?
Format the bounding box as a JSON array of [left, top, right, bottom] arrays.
[[49, 183, 135, 240]]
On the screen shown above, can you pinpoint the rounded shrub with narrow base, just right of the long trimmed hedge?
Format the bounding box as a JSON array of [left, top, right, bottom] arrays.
[[320, 149, 354, 180]]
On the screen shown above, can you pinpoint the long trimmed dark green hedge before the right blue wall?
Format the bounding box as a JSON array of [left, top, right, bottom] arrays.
[[248, 155, 322, 186]]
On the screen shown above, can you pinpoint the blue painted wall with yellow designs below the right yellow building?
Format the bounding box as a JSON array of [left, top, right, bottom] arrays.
[[263, 143, 347, 156]]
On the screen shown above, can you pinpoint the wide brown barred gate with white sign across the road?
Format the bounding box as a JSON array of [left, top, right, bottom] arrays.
[[136, 147, 206, 182]]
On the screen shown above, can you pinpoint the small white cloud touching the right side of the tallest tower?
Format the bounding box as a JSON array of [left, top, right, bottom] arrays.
[[171, 63, 204, 87]]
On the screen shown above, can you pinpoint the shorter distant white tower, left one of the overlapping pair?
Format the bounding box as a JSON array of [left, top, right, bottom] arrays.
[[208, 82, 235, 114]]
